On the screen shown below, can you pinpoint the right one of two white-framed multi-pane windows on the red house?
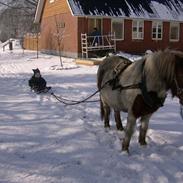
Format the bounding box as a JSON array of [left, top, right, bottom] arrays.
[[152, 22, 163, 40]]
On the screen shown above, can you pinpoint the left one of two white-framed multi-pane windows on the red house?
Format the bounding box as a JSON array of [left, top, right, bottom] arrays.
[[132, 20, 144, 39]]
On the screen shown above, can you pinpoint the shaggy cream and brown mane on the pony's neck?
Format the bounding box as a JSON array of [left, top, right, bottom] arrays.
[[146, 49, 183, 86]]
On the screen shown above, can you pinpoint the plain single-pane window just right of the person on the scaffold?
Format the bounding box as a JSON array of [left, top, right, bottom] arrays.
[[111, 20, 124, 40]]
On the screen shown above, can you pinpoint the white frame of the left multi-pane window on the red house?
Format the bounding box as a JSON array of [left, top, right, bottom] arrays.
[[132, 20, 144, 40]]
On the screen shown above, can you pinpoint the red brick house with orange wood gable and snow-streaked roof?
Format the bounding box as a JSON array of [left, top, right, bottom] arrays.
[[35, 0, 183, 57]]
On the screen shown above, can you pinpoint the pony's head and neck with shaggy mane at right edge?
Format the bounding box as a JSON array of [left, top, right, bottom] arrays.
[[146, 49, 183, 118]]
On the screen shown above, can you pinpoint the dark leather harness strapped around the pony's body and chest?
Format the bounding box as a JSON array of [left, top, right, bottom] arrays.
[[108, 59, 166, 110]]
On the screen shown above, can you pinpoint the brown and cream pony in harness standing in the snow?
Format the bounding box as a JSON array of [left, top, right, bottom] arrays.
[[97, 49, 183, 152]]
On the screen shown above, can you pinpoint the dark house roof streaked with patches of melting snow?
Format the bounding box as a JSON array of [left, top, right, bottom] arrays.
[[35, 0, 183, 22]]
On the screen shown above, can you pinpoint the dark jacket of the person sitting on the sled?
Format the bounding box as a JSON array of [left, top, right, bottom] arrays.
[[29, 76, 46, 91]]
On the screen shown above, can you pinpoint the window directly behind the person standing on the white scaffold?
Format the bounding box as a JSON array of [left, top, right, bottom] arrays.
[[88, 18, 103, 34]]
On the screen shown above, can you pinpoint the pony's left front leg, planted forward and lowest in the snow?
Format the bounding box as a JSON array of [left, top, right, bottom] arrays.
[[122, 113, 136, 152]]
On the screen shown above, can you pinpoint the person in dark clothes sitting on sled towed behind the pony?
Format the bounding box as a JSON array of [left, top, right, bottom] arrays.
[[29, 68, 51, 93]]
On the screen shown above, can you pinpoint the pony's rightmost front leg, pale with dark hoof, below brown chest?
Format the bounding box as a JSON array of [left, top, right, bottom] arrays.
[[139, 114, 152, 145]]
